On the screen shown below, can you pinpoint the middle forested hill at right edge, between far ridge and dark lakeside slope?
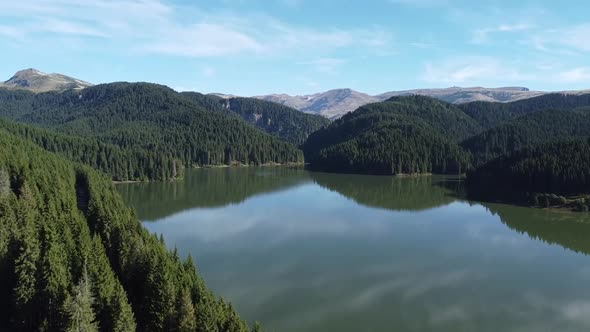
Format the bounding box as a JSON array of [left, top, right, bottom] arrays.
[[461, 109, 590, 165]]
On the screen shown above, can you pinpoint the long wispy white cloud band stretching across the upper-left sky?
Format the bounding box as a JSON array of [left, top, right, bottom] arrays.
[[0, 0, 390, 57]]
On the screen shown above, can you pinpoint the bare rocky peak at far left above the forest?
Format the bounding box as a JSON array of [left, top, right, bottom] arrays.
[[0, 68, 92, 92]]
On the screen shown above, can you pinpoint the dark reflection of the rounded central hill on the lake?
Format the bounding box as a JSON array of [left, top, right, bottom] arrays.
[[311, 173, 459, 211]]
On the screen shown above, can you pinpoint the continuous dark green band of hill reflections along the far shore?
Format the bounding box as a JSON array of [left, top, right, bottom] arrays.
[[122, 167, 590, 254]]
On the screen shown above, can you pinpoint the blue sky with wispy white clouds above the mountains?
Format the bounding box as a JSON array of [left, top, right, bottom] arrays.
[[0, 0, 590, 96]]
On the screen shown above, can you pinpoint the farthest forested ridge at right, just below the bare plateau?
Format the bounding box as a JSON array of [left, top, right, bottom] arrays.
[[458, 93, 590, 129]]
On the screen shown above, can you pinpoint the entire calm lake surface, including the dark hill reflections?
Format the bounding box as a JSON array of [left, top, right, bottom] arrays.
[[117, 167, 590, 332]]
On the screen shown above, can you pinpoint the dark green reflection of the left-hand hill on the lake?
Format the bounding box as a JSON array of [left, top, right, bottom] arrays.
[[117, 167, 310, 221]]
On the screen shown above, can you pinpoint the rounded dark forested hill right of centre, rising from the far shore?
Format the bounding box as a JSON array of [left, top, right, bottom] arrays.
[[304, 97, 478, 174]]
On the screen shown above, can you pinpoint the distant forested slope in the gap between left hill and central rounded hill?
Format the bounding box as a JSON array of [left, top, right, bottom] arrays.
[[224, 98, 330, 145]]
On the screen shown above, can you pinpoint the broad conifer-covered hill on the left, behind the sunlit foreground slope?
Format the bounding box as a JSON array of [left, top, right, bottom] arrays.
[[0, 83, 303, 172]]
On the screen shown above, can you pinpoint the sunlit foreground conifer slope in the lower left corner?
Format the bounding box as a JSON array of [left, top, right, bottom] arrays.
[[0, 130, 256, 331]]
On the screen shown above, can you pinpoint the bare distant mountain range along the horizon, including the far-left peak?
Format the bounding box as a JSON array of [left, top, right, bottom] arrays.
[[0, 68, 590, 119]]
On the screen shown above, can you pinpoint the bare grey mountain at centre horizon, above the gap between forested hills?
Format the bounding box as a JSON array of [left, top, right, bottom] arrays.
[[254, 89, 381, 118]]
